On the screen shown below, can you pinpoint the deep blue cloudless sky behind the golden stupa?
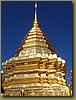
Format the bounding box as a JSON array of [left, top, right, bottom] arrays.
[[1, 1, 72, 81]]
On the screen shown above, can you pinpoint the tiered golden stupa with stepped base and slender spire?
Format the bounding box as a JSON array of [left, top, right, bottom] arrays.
[[2, 2, 70, 96]]
